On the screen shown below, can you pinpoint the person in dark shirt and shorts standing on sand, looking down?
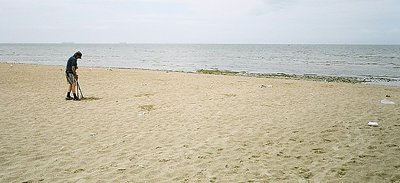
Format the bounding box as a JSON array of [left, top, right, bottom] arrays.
[[65, 51, 82, 100]]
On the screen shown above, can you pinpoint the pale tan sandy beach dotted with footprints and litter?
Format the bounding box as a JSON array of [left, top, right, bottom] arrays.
[[0, 64, 400, 182]]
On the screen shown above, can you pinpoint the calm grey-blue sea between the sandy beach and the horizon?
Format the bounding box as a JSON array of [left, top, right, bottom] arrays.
[[0, 43, 400, 86]]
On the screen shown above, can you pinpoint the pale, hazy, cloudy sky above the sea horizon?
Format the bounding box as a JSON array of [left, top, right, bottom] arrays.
[[0, 0, 400, 44]]
